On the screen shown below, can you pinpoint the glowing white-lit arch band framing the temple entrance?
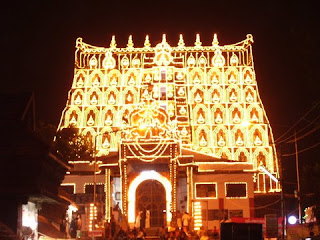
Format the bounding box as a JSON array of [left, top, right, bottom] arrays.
[[128, 171, 172, 226]]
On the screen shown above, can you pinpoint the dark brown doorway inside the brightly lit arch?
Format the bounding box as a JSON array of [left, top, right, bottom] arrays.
[[136, 180, 166, 227]]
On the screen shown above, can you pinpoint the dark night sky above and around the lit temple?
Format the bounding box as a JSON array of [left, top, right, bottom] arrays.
[[0, 0, 320, 206]]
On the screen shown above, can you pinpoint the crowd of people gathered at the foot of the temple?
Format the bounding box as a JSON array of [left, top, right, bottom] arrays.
[[65, 204, 219, 240]]
